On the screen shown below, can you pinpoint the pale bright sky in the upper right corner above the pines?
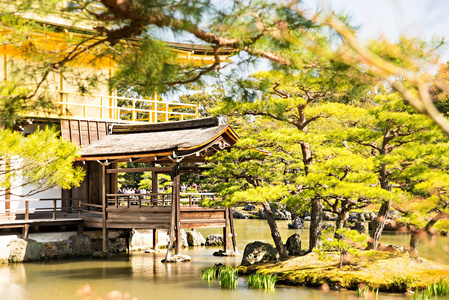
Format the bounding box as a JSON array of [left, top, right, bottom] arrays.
[[303, 0, 449, 60]]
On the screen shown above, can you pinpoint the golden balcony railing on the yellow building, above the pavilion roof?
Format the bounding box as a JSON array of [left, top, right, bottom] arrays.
[[39, 91, 199, 123]]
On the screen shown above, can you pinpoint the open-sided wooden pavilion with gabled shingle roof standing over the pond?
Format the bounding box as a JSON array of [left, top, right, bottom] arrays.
[[70, 117, 238, 258]]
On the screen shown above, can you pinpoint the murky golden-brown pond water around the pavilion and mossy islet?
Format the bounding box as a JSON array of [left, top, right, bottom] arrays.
[[0, 220, 449, 300]]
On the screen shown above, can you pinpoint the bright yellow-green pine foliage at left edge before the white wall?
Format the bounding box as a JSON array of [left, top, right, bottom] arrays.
[[0, 128, 84, 196]]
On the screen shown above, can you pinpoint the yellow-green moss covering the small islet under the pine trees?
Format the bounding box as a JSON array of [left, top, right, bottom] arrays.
[[238, 251, 449, 292]]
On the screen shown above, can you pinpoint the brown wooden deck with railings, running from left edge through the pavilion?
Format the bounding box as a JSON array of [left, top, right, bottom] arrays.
[[0, 193, 235, 254]]
